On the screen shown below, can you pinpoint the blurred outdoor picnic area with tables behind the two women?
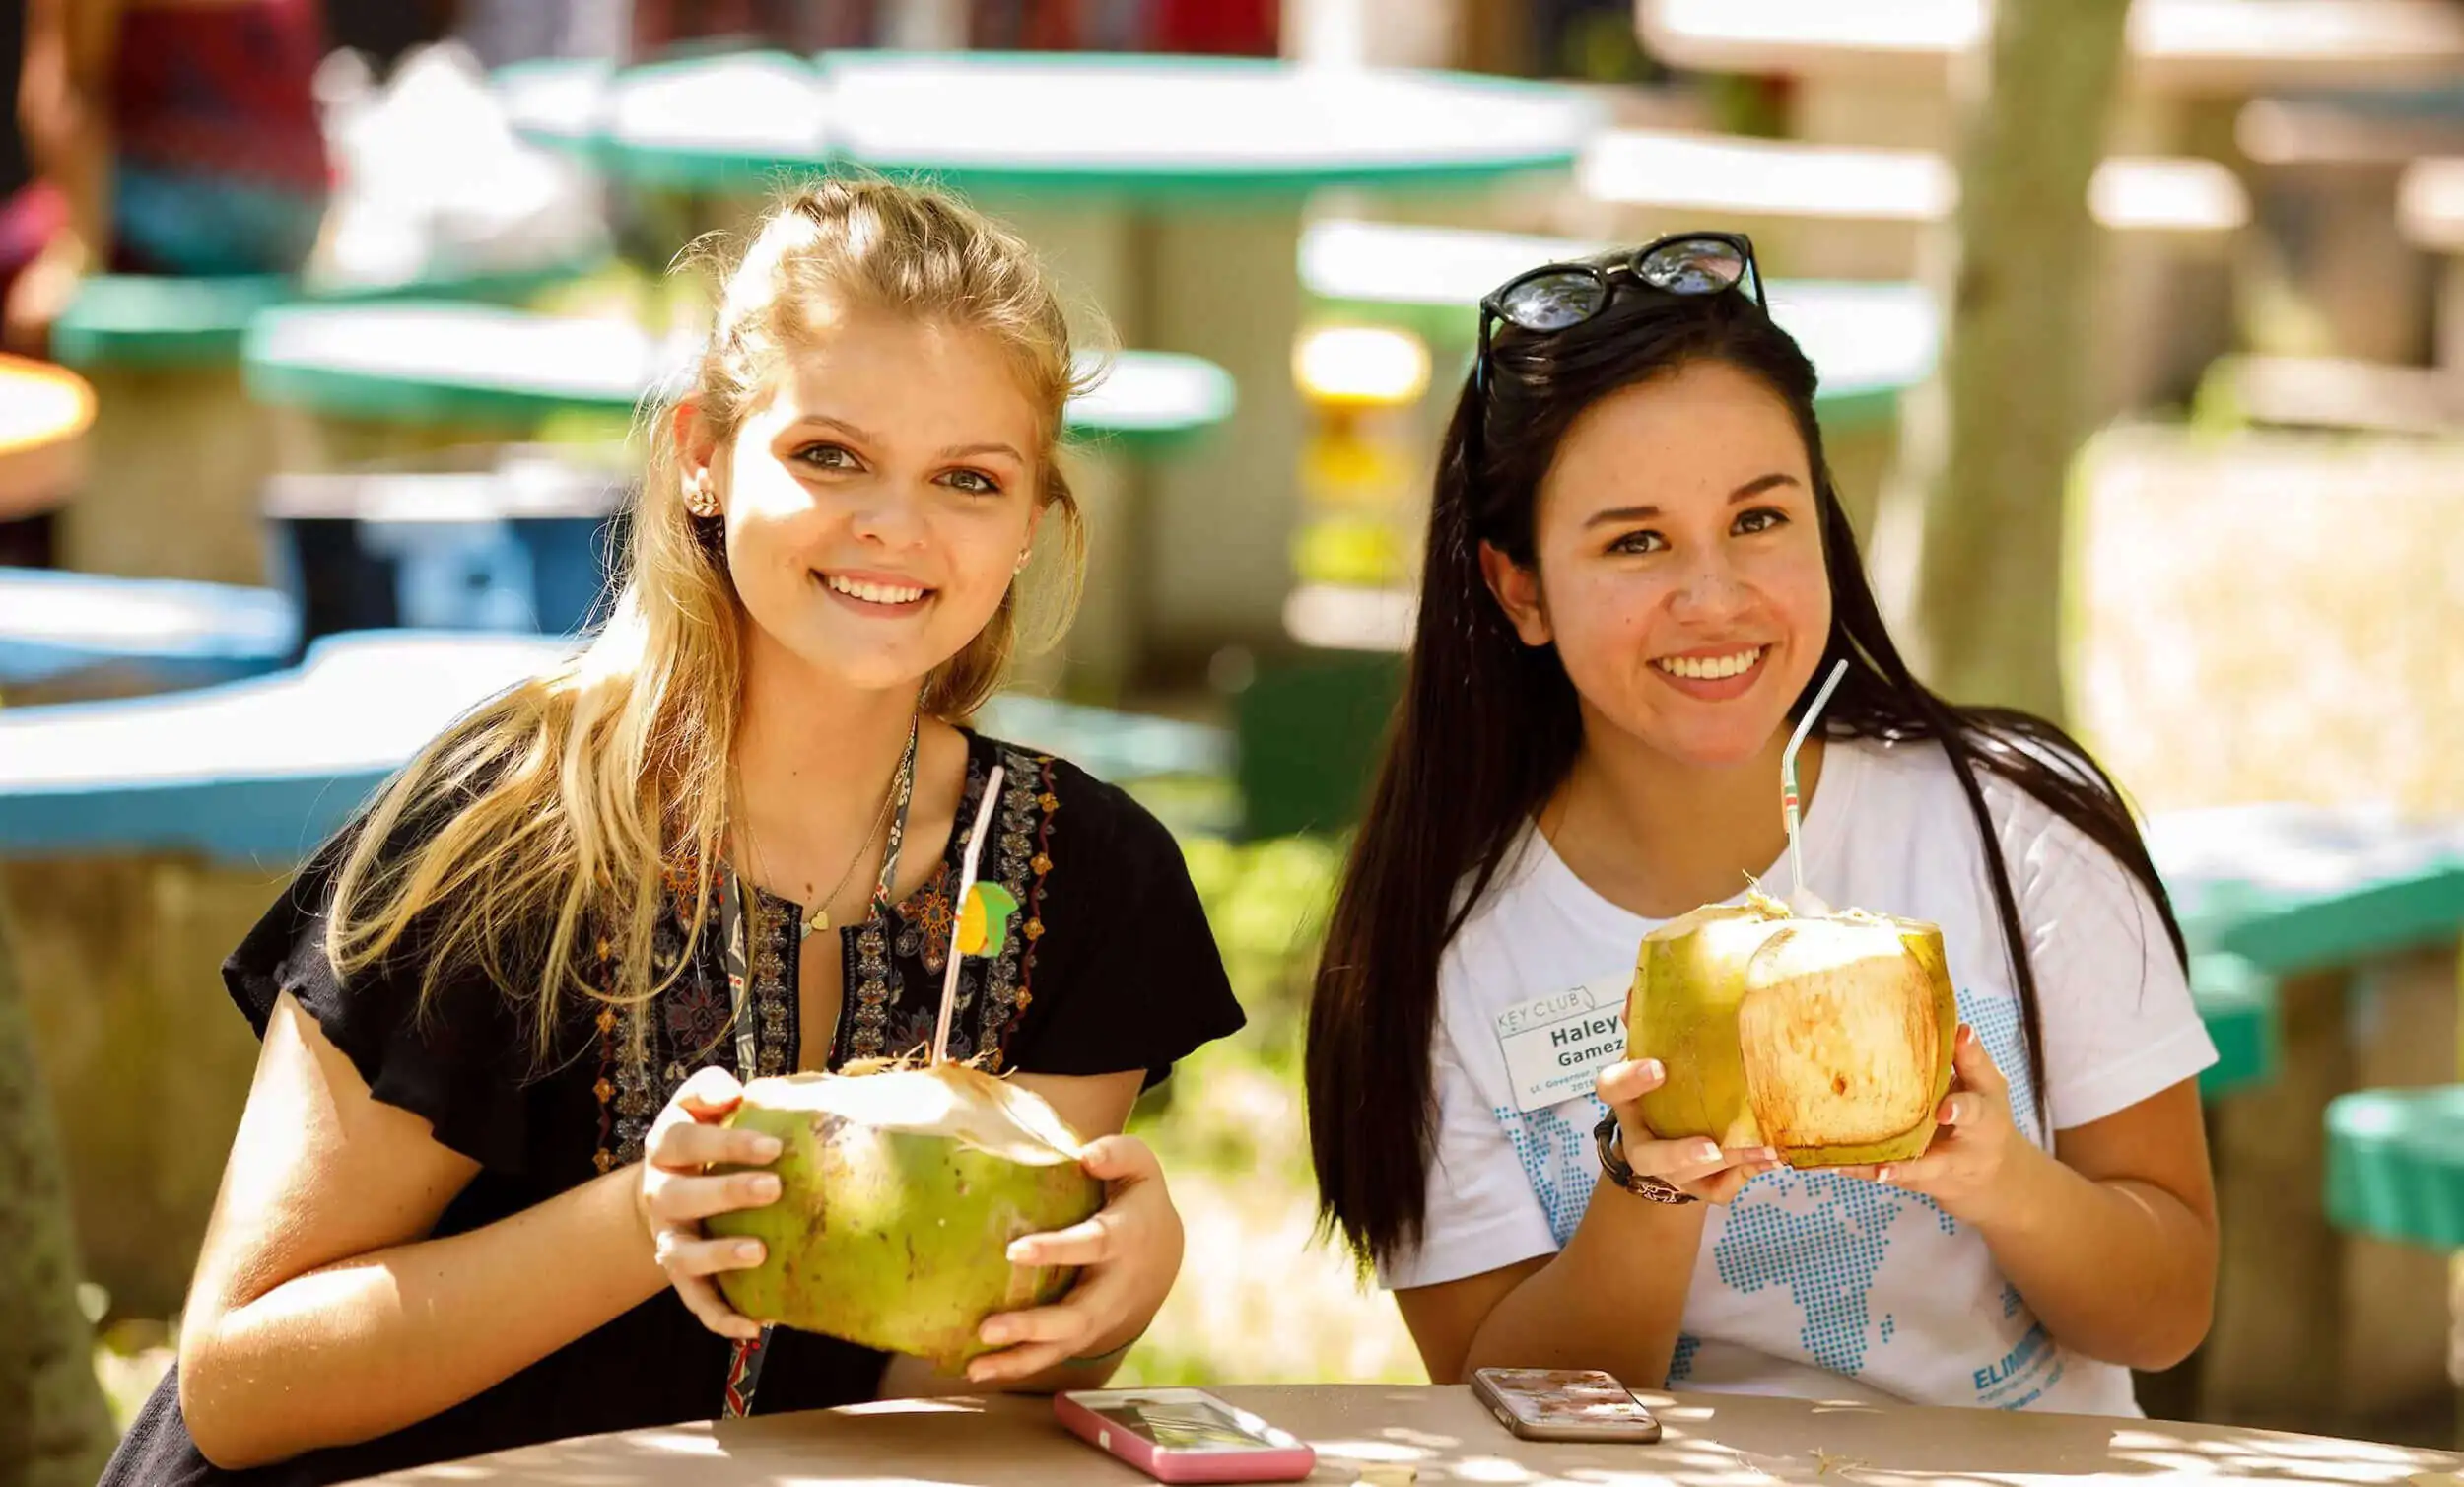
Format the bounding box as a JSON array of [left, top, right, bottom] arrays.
[[0, 0, 2464, 1482]]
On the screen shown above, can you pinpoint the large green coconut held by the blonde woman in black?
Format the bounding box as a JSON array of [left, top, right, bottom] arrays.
[[705, 1063, 1104, 1374]]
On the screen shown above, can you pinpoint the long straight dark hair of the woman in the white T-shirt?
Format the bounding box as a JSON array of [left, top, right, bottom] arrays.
[[1306, 260, 2183, 1260]]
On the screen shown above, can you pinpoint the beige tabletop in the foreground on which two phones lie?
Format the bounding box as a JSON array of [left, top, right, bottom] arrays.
[[370, 1379, 2457, 1487]]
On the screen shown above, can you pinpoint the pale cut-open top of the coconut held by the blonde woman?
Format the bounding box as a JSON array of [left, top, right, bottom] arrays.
[[739, 1063, 1087, 1167]]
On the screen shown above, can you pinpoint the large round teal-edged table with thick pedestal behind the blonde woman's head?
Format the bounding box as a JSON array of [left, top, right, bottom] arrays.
[[501, 51, 1602, 675]]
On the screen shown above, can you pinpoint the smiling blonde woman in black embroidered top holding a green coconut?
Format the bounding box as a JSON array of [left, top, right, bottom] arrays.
[[106, 182, 1242, 1487]]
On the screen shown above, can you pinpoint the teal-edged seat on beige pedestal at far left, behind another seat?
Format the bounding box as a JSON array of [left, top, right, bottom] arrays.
[[52, 263, 606, 583]]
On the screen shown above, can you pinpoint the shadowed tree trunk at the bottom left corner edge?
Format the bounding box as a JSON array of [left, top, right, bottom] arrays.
[[0, 906, 113, 1487]]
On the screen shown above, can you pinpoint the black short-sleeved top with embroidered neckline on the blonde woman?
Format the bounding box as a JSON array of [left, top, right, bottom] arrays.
[[103, 734, 1242, 1487]]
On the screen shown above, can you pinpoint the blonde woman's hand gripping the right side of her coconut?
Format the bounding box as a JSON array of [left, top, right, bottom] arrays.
[[966, 1135, 1183, 1384]]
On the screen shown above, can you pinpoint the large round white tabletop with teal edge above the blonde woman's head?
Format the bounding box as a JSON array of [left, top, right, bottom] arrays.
[[498, 51, 1602, 194]]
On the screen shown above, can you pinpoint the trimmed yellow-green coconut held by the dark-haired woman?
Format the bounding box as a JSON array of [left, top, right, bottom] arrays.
[[1626, 894, 1959, 1167]]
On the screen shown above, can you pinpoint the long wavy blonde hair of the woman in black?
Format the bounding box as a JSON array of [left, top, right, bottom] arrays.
[[328, 179, 1084, 1056]]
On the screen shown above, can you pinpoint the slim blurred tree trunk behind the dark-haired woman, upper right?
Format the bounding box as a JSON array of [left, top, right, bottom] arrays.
[[1910, 0, 2129, 719]]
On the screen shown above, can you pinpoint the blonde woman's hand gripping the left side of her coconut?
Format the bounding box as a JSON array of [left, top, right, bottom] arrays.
[[634, 1066, 779, 1342]]
